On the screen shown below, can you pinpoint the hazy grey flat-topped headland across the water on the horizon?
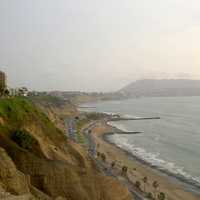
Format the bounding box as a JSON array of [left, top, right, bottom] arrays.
[[119, 79, 200, 97]]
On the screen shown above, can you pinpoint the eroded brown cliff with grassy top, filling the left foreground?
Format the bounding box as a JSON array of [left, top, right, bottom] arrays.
[[0, 98, 131, 200]]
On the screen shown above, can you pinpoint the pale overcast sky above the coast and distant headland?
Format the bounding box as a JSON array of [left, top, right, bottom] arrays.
[[0, 0, 200, 92]]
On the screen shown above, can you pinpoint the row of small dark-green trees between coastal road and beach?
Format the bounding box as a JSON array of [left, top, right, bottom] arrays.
[[97, 152, 166, 200]]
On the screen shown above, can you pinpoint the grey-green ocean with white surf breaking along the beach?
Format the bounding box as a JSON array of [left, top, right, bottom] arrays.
[[82, 97, 200, 189]]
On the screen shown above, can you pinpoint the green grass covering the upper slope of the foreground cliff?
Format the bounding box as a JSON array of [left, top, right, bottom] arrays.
[[0, 97, 66, 141]]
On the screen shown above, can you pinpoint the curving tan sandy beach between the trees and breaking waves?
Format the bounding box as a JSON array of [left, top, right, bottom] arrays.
[[91, 121, 200, 200]]
